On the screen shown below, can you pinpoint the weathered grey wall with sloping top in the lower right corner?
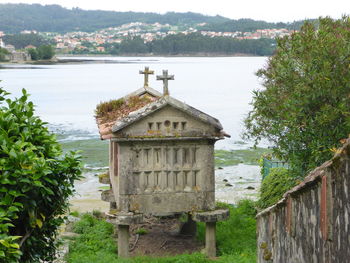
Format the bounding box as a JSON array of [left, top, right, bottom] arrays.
[[257, 139, 350, 263]]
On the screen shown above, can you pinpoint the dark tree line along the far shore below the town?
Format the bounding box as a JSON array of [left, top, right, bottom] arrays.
[[74, 33, 275, 56]]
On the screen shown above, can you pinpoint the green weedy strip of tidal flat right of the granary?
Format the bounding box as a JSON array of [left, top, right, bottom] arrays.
[[215, 147, 271, 166]]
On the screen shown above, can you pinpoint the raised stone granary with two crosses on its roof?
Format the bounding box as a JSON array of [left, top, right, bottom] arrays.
[[96, 67, 228, 257]]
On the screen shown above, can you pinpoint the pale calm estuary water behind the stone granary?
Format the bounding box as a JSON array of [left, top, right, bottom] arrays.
[[0, 57, 267, 209]]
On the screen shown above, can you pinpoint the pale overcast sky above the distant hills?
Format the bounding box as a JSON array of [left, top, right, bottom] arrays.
[[0, 0, 350, 22]]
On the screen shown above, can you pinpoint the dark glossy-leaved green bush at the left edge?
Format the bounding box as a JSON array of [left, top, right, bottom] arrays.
[[0, 88, 81, 263]]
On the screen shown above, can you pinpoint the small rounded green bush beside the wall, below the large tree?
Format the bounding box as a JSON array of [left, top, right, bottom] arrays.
[[257, 168, 297, 209]]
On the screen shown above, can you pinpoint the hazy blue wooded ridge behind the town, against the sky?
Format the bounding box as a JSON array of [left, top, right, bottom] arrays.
[[0, 4, 229, 33]]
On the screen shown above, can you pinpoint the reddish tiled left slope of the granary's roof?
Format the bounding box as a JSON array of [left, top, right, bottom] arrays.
[[96, 87, 162, 140]]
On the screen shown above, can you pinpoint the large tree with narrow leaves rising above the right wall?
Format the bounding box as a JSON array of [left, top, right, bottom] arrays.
[[244, 17, 350, 175]]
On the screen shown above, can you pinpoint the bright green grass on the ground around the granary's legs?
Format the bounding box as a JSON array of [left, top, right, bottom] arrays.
[[67, 200, 256, 263]]
